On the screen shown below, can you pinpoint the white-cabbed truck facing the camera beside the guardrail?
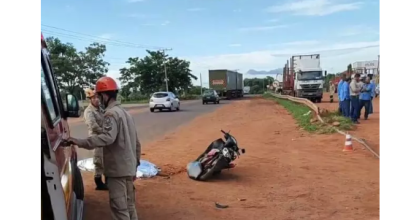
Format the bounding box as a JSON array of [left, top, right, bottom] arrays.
[[282, 54, 326, 102]]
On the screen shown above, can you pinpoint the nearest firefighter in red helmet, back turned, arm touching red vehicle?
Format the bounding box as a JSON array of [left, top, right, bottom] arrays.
[[68, 77, 141, 220]]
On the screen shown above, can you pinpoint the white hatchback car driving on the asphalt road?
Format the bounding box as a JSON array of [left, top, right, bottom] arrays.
[[149, 92, 181, 112]]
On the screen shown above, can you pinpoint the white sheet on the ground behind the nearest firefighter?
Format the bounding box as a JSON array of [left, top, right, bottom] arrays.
[[78, 158, 160, 178]]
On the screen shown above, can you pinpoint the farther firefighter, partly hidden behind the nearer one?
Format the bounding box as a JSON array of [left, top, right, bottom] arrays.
[[83, 89, 108, 190]]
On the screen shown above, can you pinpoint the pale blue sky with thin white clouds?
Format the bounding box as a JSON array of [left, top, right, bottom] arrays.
[[42, 0, 379, 86]]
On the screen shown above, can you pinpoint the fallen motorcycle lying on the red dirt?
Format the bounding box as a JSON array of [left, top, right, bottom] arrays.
[[186, 130, 246, 181]]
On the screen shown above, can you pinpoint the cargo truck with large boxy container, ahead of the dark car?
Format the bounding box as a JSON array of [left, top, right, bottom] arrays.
[[208, 69, 243, 99]]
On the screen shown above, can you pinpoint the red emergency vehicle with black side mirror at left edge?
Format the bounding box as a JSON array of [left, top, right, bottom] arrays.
[[40, 35, 84, 220]]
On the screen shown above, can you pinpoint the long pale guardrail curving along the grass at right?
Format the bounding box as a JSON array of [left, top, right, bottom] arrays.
[[267, 92, 379, 159]]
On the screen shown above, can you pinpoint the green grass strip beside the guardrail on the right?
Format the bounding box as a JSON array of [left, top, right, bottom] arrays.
[[264, 94, 353, 134]]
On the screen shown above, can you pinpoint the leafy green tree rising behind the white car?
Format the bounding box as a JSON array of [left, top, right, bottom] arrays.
[[119, 50, 197, 94]]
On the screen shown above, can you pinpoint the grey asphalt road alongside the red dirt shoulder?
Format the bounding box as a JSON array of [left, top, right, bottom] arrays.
[[70, 100, 231, 159]]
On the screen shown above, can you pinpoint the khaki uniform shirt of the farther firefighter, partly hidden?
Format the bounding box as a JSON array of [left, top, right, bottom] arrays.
[[83, 104, 104, 158]]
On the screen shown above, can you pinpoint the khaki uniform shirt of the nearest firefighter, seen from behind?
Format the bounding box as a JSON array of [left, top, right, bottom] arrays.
[[77, 101, 141, 177]]
